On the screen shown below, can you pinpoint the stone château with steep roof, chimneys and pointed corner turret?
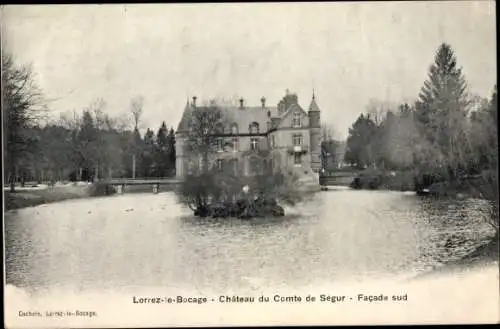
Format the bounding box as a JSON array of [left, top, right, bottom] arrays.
[[176, 91, 321, 181]]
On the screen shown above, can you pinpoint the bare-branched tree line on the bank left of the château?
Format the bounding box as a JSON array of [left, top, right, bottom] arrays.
[[2, 54, 175, 190]]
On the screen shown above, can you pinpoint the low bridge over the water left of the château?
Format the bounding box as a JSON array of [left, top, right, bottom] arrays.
[[103, 178, 181, 194]]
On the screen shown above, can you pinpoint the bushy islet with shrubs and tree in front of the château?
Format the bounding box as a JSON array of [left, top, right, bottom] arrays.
[[179, 102, 308, 218]]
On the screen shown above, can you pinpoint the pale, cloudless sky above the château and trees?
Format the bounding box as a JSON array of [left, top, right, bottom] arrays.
[[1, 0, 497, 138]]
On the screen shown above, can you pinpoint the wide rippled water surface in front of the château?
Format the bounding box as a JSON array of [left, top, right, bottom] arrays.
[[5, 189, 494, 294]]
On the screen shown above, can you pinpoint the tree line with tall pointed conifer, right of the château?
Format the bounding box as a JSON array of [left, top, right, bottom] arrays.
[[345, 43, 498, 180]]
